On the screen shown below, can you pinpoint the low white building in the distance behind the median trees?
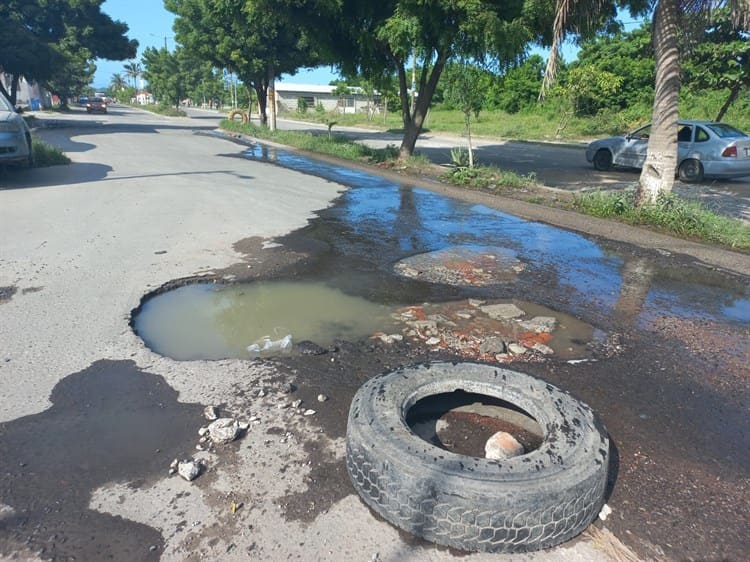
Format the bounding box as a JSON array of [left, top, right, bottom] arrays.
[[276, 82, 380, 113]]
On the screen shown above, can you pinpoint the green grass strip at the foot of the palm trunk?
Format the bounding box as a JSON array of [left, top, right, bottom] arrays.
[[573, 190, 750, 251]]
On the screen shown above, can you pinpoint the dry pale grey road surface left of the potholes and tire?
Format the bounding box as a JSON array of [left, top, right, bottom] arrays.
[[0, 107, 636, 562]]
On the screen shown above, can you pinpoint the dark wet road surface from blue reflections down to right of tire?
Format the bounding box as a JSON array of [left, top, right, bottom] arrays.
[[232, 143, 750, 560]]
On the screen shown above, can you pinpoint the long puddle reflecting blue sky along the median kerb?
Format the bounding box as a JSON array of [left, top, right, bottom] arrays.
[[244, 146, 750, 326]]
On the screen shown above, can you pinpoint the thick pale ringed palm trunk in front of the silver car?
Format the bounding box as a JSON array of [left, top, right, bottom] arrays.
[[636, 0, 680, 205]]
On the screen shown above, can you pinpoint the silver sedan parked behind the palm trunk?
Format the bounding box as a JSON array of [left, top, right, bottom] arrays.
[[586, 121, 750, 182]]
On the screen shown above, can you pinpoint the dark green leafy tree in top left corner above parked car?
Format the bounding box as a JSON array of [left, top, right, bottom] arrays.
[[0, 0, 138, 103]]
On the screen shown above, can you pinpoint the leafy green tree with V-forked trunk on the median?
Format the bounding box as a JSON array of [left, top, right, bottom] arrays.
[[322, 0, 538, 157]]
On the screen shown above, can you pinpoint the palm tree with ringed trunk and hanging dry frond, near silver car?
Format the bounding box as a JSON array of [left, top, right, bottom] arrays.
[[543, 0, 750, 205]]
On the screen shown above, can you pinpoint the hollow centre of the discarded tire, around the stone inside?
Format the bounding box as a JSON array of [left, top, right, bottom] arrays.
[[406, 391, 544, 458]]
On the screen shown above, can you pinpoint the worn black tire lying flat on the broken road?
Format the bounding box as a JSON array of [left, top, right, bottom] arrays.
[[346, 363, 609, 552]]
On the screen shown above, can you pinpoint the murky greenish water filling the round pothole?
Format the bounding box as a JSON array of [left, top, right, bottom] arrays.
[[135, 281, 400, 361]]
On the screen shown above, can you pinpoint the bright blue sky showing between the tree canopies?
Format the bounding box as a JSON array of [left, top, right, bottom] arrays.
[[93, 0, 638, 89]]
